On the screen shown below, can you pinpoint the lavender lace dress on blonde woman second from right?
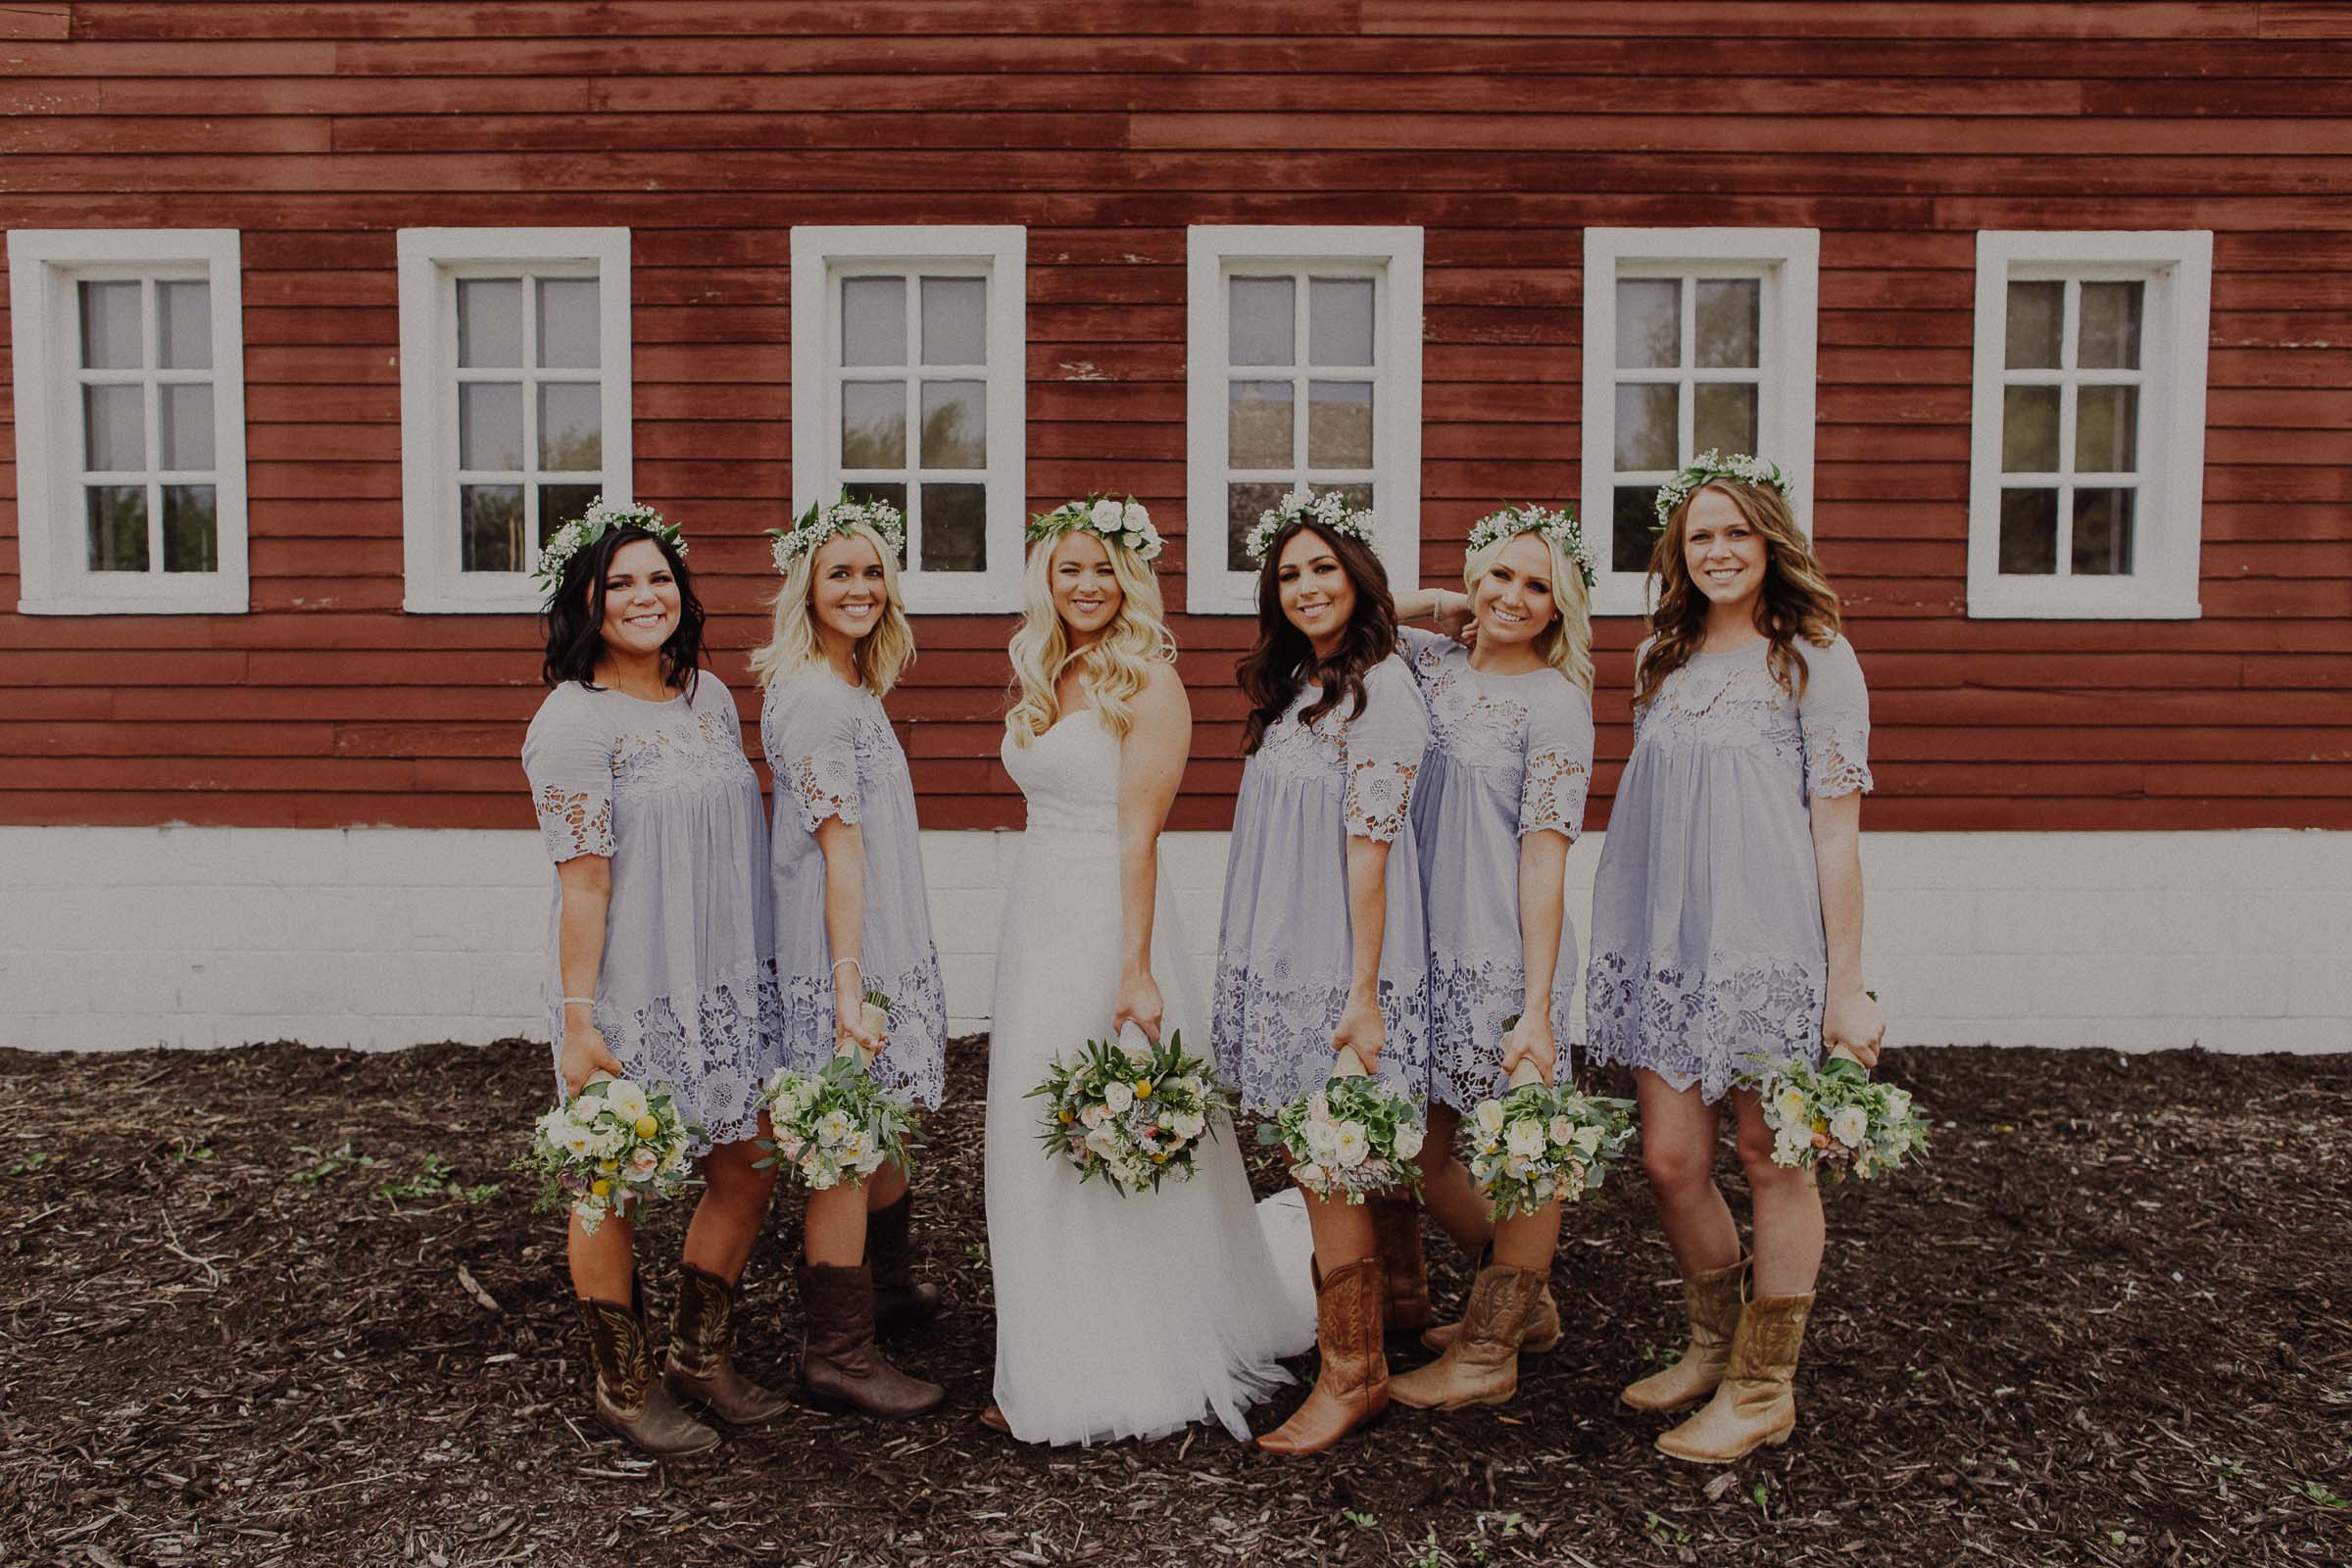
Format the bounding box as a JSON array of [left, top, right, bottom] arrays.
[[1404, 627, 1592, 1109]]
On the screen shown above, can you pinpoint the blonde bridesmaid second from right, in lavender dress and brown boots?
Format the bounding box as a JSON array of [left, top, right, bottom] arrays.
[[1388, 508, 1592, 1410]]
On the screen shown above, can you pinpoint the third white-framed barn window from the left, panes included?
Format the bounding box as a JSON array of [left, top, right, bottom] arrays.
[[793, 225, 1028, 612]]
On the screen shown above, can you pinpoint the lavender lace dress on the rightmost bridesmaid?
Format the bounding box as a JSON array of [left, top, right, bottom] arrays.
[[1586, 637, 1870, 1102]]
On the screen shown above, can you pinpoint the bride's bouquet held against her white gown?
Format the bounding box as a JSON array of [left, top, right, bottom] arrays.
[[1025, 1022, 1235, 1192]]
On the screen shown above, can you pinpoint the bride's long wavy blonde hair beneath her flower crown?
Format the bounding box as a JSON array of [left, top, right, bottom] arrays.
[[1004, 529, 1176, 745]]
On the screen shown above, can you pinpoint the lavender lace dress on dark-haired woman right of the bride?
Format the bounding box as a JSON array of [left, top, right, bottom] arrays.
[[1209, 656, 1430, 1109]]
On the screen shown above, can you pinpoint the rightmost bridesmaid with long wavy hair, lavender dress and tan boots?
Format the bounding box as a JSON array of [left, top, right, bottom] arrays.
[[1586, 452, 1886, 1464]]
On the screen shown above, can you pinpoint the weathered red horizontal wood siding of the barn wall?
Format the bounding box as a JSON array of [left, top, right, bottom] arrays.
[[0, 0, 2352, 830]]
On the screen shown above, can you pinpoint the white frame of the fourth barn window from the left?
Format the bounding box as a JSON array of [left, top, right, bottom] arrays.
[[1186, 223, 1421, 615]]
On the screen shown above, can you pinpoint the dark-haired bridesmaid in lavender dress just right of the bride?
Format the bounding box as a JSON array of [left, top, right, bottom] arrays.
[[1211, 491, 1430, 1452]]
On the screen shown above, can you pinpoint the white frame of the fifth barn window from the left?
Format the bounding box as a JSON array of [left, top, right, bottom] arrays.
[[1576, 228, 1821, 615]]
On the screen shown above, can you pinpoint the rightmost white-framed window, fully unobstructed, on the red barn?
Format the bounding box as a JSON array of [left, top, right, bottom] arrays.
[[1969, 232, 2213, 618]]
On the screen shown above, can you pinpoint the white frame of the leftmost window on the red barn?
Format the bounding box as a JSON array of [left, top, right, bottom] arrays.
[[7, 228, 252, 615]]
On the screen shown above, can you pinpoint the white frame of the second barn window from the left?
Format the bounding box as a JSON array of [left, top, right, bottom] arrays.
[[398, 228, 635, 615]]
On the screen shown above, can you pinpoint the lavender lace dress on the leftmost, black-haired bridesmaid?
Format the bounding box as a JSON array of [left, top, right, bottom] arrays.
[[522, 672, 783, 1154]]
